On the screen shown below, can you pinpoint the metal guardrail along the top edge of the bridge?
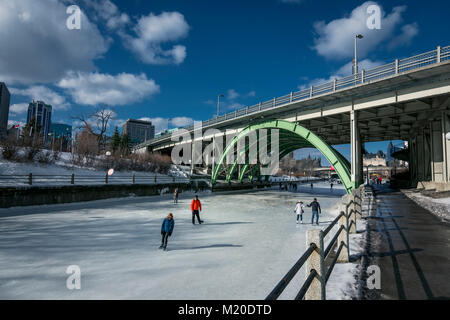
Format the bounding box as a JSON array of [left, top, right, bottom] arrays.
[[134, 46, 450, 149]]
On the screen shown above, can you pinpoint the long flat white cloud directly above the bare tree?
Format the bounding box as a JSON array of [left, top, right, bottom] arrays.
[[58, 72, 159, 106]]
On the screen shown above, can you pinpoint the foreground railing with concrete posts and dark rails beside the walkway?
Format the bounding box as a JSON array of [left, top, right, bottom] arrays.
[[266, 186, 365, 300]]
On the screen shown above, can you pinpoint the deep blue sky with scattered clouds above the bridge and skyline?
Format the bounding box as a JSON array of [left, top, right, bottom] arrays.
[[0, 0, 450, 161]]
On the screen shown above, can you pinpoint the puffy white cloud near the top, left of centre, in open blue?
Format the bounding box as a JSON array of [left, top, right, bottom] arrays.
[[121, 12, 189, 64]]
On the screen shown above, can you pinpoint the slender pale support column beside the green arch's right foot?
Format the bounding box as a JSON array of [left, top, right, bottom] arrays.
[[350, 110, 363, 189]]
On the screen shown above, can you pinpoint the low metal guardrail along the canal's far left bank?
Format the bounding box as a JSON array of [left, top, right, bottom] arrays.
[[0, 173, 190, 187]]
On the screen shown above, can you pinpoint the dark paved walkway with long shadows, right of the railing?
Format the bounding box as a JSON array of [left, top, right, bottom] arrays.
[[368, 192, 450, 300]]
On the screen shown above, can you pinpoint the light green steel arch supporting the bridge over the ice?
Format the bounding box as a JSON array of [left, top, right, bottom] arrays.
[[211, 120, 354, 193]]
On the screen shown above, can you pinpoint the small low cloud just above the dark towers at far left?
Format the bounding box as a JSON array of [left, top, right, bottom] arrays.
[[10, 85, 70, 110]]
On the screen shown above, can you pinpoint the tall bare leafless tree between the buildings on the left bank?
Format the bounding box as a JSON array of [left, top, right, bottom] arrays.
[[74, 108, 115, 151]]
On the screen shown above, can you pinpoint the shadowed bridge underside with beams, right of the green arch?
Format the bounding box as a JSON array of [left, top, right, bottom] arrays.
[[298, 94, 450, 185]]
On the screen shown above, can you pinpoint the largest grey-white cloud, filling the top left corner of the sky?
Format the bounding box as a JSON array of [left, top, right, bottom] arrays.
[[0, 0, 108, 84]]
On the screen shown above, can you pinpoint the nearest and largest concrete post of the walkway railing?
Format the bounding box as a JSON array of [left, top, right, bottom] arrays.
[[305, 229, 325, 300]]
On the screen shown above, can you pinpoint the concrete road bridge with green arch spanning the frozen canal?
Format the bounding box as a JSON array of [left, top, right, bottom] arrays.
[[134, 46, 450, 192]]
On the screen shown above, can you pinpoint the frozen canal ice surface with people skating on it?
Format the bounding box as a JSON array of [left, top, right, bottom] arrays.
[[0, 184, 344, 299]]
